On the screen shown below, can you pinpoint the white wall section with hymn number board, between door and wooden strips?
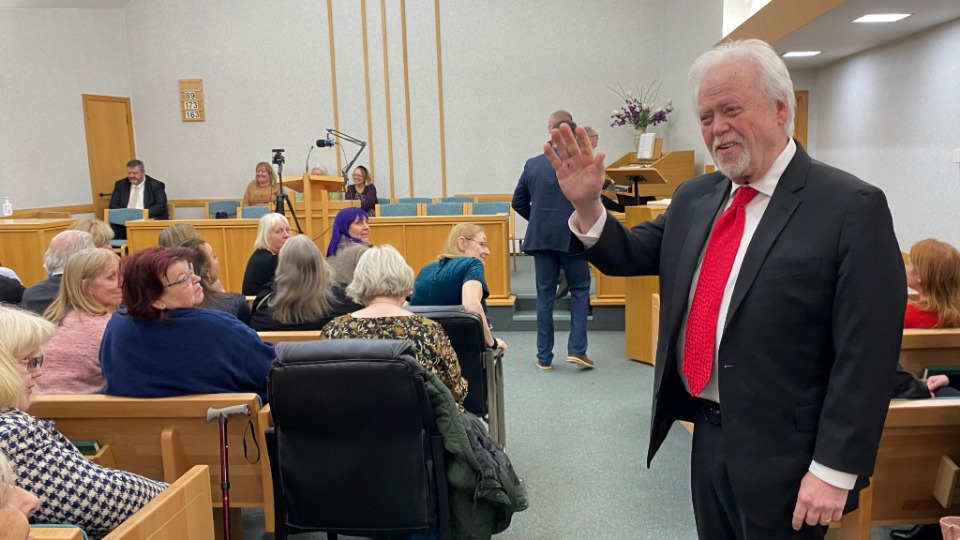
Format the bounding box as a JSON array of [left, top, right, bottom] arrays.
[[125, 0, 332, 199]]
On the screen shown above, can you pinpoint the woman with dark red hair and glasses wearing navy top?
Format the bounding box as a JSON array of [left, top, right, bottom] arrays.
[[100, 247, 273, 402]]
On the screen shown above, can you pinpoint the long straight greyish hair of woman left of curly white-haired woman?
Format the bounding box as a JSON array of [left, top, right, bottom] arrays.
[[267, 235, 333, 324]]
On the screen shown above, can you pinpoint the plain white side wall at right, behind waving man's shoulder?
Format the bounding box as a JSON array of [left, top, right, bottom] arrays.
[[817, 19, 960, 250]]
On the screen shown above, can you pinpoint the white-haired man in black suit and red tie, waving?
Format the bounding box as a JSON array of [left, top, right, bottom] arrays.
[[544, 40, 906, 540]]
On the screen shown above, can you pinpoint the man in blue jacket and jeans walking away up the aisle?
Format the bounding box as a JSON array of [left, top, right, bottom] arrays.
[[512, 110, 593, 371]]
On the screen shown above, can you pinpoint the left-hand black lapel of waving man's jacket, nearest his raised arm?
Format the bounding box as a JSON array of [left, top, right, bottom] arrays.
[[669, 178, 730, 340]]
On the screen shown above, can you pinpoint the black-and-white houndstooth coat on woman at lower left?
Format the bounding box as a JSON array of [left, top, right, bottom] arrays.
[[0, 408, 167, 538]]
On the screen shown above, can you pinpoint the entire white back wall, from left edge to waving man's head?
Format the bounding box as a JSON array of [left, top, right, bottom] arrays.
[[0, 0, 720, 211]]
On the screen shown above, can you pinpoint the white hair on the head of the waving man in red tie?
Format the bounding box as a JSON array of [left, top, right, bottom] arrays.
[[689, 39, 797, 137]]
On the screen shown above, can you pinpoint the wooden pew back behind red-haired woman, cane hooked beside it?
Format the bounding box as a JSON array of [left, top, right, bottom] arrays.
[[30, 392, 274, 531]]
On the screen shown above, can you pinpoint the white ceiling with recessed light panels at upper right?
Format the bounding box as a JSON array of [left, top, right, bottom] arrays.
[[773, 0, 960, 69]]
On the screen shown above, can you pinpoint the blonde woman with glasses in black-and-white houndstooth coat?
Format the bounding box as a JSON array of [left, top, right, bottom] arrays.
[[0, 306, 167, 537]]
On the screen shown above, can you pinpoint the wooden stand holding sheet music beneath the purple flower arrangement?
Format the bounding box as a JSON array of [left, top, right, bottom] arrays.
[[606, 139, 694, 206]]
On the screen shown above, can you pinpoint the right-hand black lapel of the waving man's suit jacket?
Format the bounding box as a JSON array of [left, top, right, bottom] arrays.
[[725, 150, 810, 325]]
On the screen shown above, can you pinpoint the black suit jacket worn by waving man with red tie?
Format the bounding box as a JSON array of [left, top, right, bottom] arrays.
[[572, 145, 906, 528]]
